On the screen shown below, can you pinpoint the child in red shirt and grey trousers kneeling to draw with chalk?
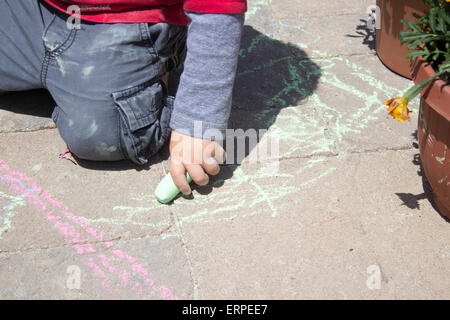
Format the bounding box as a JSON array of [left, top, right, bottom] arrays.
[[0, 0, 247, 194]]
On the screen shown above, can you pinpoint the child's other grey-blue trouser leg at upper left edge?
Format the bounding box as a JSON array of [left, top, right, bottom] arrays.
[[0, 0, 50, 92]]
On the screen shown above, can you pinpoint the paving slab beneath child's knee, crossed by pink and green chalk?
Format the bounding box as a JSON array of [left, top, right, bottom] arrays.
[[0, 130, 173, 251]]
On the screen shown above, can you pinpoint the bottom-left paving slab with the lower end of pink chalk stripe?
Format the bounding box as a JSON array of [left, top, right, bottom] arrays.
[[0, 235, 193, 299]]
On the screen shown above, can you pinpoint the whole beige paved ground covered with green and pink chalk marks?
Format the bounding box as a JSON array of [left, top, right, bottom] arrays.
[[0, 0, 450, 299]]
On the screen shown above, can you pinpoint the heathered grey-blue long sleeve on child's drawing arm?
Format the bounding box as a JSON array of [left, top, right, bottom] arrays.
[[170, 12, 245, 139]]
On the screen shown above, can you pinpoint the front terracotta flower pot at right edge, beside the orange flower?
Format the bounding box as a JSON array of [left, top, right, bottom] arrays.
[[411, 57, 450, 218]]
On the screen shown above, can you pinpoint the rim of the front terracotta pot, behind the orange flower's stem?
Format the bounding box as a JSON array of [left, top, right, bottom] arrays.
[[411, 56, 450, 121]]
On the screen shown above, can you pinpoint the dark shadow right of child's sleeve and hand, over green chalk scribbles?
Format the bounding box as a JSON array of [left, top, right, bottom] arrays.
[[192, 26, 322, 194]]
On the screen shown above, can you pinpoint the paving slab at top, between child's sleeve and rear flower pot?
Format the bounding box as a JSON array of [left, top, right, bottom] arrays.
[[246, 0, 375, 58]]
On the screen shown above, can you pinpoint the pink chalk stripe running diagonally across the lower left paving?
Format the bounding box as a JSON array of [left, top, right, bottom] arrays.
[[0, 159, 179, 300]]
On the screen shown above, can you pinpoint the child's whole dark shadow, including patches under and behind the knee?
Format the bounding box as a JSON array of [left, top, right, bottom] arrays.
[[0, 26, 321, 198]]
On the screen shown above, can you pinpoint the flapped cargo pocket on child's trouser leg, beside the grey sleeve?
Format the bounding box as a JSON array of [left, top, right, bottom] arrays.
[[112, 82, 173, 164]]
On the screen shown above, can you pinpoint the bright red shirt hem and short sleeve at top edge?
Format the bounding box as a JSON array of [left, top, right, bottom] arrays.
[[45, 0, 247, 25]]
